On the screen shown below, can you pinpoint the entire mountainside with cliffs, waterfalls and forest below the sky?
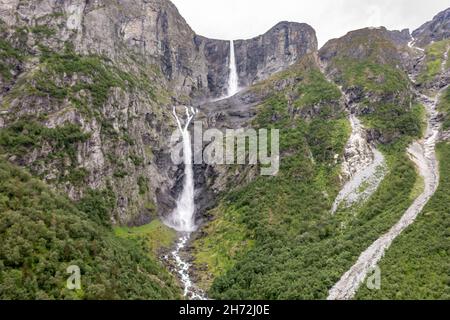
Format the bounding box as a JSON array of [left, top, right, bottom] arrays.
[[0, 0, 450, 300]]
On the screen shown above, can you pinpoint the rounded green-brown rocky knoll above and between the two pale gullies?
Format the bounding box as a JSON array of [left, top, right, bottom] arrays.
[[322, 34, 422, 142]]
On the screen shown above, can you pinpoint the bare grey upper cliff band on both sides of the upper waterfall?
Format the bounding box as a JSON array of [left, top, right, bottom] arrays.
[[0, 0, 317, 99]]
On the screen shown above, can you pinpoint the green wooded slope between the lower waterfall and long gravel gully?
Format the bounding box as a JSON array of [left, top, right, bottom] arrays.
[[192, 54, 420, 299]]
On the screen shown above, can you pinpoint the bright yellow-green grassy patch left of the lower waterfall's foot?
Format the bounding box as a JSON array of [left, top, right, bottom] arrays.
[[114, 219, 176, 254]]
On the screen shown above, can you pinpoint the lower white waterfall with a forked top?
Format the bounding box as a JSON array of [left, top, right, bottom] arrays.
[[168, 107, 196, 232]]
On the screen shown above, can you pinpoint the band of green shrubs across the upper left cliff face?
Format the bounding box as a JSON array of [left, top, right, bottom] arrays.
[[4, 45, 154, 118]]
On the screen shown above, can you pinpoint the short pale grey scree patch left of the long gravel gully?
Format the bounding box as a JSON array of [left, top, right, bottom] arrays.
[[331, 114, 386, 214]]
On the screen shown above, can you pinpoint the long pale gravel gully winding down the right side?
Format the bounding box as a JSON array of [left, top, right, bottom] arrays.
[[328, 39, 448, 300]]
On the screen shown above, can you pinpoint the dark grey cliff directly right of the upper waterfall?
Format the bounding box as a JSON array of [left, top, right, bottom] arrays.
[[235, 22, 317, 87]]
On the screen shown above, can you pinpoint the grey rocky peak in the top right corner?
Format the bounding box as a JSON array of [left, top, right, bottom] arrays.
[[412, 8, 450, 48]]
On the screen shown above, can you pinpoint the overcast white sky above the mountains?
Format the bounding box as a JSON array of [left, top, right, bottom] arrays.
[[171, 0, 450, 47]]
